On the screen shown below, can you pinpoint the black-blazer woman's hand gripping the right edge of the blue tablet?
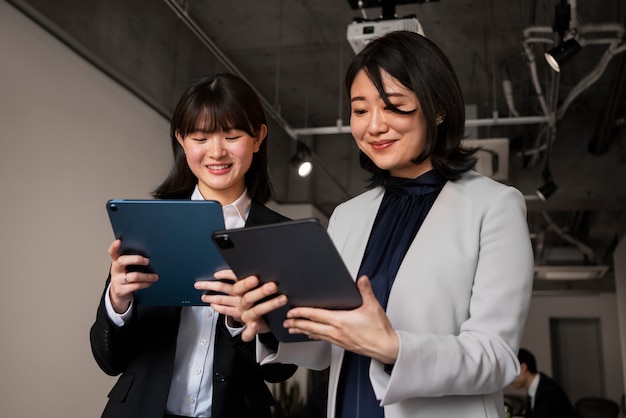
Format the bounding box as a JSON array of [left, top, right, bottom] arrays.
[[194, 270, 241, 326]]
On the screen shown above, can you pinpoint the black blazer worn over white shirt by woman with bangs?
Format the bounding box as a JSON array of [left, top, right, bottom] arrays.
[[90, 203, 297, 418]]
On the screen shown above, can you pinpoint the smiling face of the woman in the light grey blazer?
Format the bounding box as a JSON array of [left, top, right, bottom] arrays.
[[350, 70, 432, 178]]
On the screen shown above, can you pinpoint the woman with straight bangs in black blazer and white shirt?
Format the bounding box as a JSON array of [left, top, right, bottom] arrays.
[[90, 74, 297, 418]]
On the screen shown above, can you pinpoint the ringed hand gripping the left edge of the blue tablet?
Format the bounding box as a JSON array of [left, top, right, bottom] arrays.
[[109, 239, 159, 314]]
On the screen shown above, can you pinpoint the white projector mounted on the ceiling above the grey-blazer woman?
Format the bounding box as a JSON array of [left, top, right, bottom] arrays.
[[347, 17, 426, 54]]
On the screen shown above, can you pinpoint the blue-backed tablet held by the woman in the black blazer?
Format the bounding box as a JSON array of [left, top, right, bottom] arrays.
[[106, 199, 228, 306]]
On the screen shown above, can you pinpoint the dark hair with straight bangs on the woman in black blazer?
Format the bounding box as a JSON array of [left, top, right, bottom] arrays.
[[152, 73, 274, 203]]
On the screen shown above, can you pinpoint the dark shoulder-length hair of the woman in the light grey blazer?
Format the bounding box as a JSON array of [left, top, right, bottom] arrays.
[[346, 31, 476, 186]]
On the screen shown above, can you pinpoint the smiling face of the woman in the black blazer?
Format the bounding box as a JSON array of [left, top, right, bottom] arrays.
[[176, 125, 267, 205]]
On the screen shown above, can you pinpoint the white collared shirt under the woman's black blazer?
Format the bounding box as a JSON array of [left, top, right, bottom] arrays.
[[105, 186, 251, 417]]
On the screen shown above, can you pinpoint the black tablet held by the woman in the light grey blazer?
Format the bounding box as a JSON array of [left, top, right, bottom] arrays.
[[212, 218, 362, 342]]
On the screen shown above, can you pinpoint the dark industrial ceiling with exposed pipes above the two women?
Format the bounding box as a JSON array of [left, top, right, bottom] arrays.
[[8, 0, 626, 292]]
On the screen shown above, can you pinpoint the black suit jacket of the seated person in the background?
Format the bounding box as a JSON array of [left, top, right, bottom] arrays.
[[524, 373, 578, 418]]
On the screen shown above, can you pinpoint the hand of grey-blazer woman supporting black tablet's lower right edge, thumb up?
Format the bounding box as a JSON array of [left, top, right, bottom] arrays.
[[283, 276, 399, 364]]
